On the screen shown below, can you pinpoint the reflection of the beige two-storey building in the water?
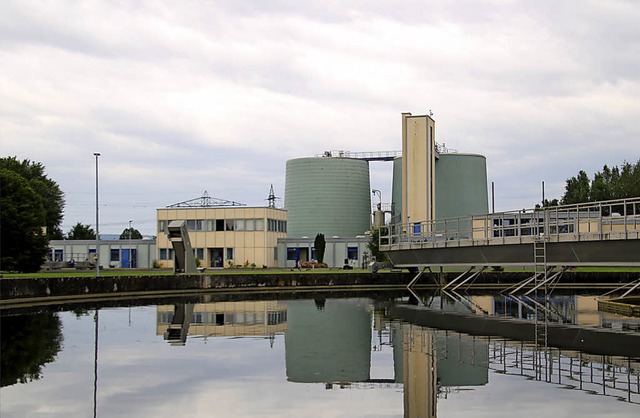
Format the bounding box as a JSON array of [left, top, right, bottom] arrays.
[[156, 301, 287, 343]]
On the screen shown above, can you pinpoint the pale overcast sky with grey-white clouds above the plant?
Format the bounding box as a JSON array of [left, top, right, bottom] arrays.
[[0, 0, 640, 235]]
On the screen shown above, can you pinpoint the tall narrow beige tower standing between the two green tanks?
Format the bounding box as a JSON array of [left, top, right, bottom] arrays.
[[402, 113, 436, 232]]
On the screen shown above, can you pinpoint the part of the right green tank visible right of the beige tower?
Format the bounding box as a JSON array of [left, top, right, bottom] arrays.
[[436, 153, 489, 219]]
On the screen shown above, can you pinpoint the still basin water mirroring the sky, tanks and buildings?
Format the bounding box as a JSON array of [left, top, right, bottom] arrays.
[[0, 295, 640, 418]]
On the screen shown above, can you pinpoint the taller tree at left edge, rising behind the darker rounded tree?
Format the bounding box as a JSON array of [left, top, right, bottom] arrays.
[[0, 157, 65, 239]]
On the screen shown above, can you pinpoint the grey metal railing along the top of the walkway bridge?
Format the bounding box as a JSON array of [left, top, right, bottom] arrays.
[[380, 197, 640, 251]]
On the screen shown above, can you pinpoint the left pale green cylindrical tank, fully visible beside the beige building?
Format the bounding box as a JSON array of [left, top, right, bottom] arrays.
[[285, 157, 371, 238]]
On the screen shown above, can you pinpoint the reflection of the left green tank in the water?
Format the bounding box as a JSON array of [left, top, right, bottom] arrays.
[[285, 299, 371, 383]]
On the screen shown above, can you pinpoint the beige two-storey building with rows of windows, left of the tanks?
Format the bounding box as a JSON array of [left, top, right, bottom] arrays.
[[157, 194, 287, 268]]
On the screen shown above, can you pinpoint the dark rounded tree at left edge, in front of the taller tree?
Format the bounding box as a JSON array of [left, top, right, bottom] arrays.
[[0, 165, 49, 273]]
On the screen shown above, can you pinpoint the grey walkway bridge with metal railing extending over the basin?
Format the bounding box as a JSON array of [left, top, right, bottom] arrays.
[[380, 197, 640, 270]]
